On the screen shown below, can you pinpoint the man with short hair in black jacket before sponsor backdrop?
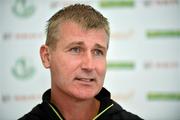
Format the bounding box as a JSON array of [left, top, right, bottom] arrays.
[[20, 4, 141, 120]]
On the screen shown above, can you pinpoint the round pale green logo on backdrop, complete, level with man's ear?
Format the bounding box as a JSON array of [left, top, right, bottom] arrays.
[[12, 57, 35, 80]]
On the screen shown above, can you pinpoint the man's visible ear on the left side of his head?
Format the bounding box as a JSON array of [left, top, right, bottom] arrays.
[[40, 45, 50, 68]]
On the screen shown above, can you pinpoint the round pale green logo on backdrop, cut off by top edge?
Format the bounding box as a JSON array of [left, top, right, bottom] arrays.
[[12, 0, 35, 17]]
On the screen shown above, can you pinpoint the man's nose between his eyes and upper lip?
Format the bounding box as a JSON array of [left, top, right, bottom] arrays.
[[81, 52, 95, 71]]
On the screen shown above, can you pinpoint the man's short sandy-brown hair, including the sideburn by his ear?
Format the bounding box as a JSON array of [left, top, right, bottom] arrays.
[[45, 4, 110, 48]]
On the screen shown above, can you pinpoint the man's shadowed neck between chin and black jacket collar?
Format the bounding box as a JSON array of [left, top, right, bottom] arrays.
[[51, 89, 100, 120]]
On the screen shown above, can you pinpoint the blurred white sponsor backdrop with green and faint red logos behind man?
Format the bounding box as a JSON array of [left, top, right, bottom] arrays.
[[0, 0, 180, 120]]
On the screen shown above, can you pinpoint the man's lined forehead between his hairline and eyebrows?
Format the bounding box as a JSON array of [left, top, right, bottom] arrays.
[[58, 21, 108, 47]]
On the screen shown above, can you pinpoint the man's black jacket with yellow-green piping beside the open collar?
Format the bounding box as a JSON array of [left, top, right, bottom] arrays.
[[18, 88, 142, 120]]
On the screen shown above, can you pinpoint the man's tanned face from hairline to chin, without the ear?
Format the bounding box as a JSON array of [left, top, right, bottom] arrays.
[[49, 21, 107, 100]]
